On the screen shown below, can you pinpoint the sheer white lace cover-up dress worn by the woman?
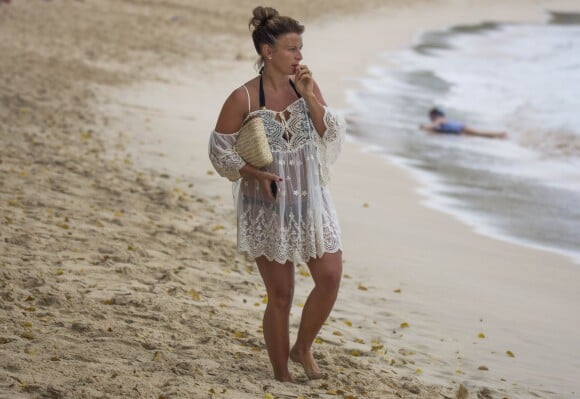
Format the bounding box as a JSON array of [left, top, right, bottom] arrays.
[[209, 91, 346, 264]]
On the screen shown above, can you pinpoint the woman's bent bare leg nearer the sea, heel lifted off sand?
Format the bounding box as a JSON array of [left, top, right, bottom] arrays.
[[290, 251, 342, 379]]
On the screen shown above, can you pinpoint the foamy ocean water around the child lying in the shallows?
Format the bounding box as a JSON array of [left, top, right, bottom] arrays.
[[349, 13, 580, 262]]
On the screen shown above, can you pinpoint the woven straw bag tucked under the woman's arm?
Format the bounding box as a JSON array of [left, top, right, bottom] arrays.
[[235, 116, 273, 169]]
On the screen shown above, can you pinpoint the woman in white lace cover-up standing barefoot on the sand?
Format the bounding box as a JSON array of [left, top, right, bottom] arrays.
[[209, 7, 345, 381]]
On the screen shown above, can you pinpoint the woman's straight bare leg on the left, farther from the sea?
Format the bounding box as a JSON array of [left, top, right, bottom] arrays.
[[256, 257, 294, 381]]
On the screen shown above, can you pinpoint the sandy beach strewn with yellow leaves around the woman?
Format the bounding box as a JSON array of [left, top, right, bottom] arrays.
[[0, 0, 580, 399]]
